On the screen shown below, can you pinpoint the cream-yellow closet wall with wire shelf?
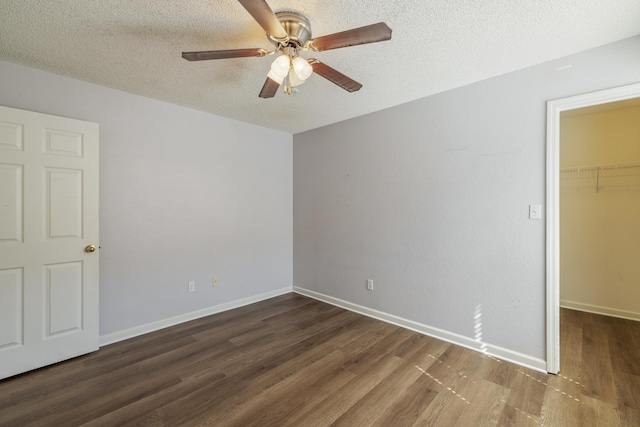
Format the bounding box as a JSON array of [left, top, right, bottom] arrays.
[[560, 103, 640, 320]]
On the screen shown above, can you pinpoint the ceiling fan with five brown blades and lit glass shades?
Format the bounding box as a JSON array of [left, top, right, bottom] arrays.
[[182, 0, 391, 98]]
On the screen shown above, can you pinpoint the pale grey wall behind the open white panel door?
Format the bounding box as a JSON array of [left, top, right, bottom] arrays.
[[0, 62, 292, 335]]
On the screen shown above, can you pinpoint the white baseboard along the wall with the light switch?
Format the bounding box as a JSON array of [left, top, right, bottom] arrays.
[[293, 286, 547, 373]]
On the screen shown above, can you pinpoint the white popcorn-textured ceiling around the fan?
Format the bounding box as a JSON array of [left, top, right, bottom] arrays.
[[0, 0, 640, 133]]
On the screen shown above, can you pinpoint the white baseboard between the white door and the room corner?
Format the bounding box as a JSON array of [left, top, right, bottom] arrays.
[[100, 287, 292, 347]]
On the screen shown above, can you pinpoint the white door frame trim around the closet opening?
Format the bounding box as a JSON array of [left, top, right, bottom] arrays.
[[546, 83, 640, 374]]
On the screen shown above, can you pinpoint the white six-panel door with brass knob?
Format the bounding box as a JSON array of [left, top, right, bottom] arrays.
[[0, 106, 98, 379]]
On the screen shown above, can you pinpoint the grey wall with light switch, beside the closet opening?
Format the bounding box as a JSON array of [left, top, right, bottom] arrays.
[[293, 37, 640, 368]]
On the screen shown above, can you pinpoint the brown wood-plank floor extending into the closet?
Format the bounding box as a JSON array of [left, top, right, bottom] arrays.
[[0, 294, 640, 427]]
